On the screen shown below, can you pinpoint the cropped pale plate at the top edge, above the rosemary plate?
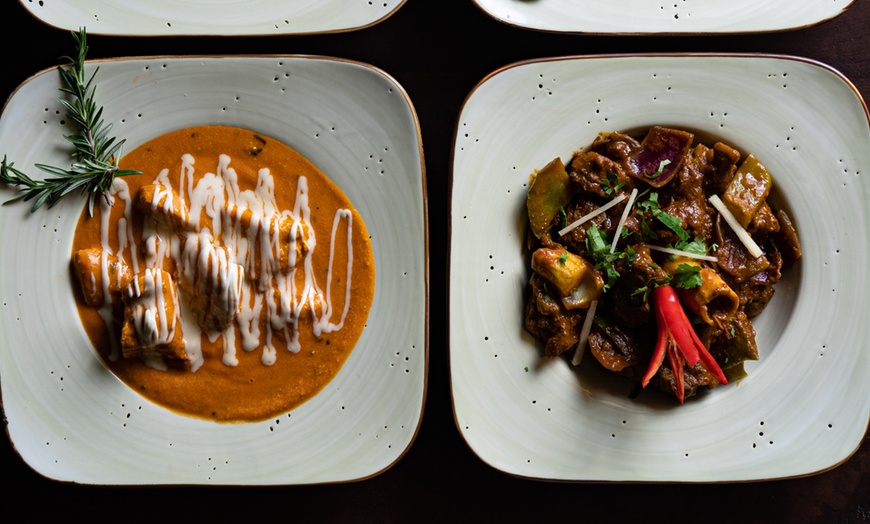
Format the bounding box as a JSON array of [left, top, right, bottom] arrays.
[[19, 0, 405, 36]]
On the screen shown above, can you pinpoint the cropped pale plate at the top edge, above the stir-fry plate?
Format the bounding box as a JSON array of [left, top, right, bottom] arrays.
[[474, 0, 855, 34]]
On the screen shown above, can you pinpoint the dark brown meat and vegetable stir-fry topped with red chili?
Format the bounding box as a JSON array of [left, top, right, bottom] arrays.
[[524, 126, 801, 402]]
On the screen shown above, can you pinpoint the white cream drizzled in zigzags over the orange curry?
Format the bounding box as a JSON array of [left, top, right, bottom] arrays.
[[100, 154, 353, 371]]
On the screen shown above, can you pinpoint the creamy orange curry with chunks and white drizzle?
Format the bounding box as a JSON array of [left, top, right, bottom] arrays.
[[72, 126, 375, 422]]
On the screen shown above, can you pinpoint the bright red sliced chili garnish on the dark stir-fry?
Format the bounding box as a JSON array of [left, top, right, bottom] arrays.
[[641, 286, 728, 403]]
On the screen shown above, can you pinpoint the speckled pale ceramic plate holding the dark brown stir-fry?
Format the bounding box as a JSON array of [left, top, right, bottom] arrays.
[[449, 55, 870, 482]]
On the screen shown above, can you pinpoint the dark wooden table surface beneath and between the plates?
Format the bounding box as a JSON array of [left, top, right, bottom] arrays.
[[0, 0, 870, 523]]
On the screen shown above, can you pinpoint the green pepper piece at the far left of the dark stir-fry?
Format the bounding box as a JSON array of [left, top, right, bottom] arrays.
[[526, 158, 571, 238]]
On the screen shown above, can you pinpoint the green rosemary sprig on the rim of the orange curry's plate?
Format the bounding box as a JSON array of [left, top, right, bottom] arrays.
[[0, 28, 139, 216]]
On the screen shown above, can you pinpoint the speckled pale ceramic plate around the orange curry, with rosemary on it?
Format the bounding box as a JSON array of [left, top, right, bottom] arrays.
[[0, 56, 428, 485]]
